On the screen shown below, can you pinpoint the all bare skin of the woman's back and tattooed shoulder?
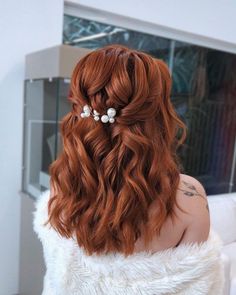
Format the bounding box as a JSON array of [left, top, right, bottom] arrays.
[[135, 174, 210, 252]]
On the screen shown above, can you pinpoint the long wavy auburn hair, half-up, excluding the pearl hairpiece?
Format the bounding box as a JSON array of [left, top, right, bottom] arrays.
[[46, 45, 186, 256]]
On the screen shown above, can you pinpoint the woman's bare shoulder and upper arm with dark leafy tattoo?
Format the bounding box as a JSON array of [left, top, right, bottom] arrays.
[[176, 174, 210, 243]]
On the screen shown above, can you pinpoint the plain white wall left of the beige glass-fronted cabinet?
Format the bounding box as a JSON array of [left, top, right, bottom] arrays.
[[0, 0, 63, 295]]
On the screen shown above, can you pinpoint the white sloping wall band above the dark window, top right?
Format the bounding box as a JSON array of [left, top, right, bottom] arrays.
[[65, 0, 236, 52]]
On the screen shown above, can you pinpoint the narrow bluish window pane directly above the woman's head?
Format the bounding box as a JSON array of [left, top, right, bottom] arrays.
[[63, 15, 170, 62]]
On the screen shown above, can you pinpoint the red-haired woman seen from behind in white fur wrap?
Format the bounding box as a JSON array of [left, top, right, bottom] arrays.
[[34, 45, 223, 295]]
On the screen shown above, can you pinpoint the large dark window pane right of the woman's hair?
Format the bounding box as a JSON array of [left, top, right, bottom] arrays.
[[172, 42, 236, 194]]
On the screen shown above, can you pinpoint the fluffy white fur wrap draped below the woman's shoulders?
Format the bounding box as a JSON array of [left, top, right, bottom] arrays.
[[33, 191, 224, 295]]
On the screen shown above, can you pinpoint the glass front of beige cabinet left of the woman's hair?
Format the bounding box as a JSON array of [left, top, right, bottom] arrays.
[[22, 78, 69, 197]]
